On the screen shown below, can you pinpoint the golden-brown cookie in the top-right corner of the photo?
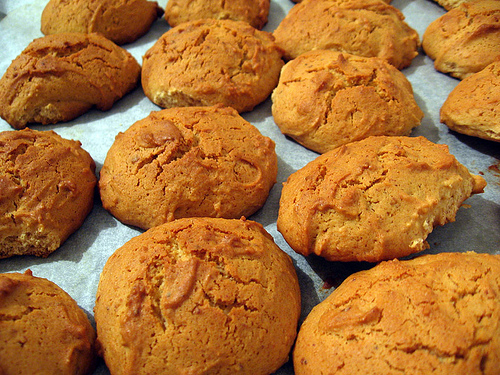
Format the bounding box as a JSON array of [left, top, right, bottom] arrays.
[[422, 0, 500, 79]]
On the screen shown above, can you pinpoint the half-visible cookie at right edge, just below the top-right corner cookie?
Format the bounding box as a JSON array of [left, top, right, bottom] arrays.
[[440, 60, 500, 142]]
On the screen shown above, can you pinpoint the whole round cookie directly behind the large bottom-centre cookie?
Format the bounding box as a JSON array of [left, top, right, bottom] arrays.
[[99, 105, 278, 229]]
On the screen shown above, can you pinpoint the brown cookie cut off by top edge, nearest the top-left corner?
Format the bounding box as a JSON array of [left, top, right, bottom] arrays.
[[41, 0, 163, 44]]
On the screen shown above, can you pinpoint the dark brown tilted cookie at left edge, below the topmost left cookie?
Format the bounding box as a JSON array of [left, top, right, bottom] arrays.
[[0, 33, 141, 129]]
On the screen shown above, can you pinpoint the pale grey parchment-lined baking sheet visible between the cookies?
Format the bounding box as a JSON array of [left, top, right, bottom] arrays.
[[0, 0, 500, 374]]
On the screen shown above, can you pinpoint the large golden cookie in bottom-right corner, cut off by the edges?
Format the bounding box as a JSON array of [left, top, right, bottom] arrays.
[[293, 253, 500, 375]]
